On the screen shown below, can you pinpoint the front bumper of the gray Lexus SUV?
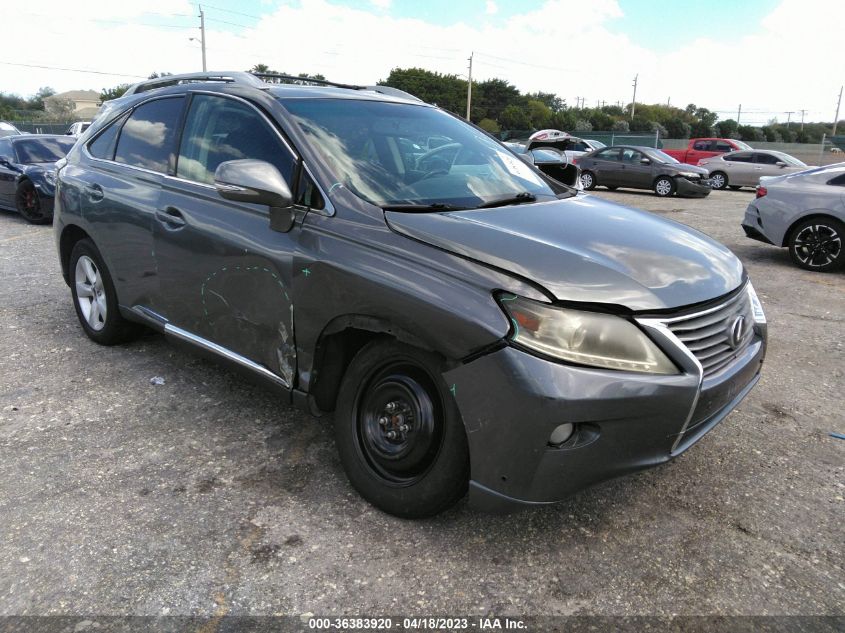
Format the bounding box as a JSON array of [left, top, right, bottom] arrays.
[[445, 326, 766, 512]]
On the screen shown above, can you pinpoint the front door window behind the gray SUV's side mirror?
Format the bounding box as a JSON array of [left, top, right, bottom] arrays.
[[176, 95, 294, 184]]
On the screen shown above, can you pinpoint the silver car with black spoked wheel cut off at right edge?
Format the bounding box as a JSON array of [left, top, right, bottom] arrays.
[[742, 163, 845, 272]]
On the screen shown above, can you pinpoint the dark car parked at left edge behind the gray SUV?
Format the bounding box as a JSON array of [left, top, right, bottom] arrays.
[[0, 134, 74, 224]]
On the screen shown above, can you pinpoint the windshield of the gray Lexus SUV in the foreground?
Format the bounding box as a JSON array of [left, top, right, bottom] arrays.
[[280, 99, 555, 210]]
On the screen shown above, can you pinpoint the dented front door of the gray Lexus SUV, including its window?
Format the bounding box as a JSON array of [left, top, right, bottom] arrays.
[[154, 93, 299, 386]]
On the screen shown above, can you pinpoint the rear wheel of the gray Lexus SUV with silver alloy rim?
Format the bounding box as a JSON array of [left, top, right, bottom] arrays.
[[68, 239, 142, 345]]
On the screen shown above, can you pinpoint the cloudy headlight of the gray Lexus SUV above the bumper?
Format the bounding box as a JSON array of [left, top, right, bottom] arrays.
[[499, 294, 678, 374]]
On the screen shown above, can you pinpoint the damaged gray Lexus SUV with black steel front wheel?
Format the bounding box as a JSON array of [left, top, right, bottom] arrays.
[[55, 73, 766, 517]]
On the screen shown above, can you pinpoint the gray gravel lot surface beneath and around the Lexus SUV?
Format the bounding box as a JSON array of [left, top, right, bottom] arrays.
[[0, 190, 845, 616]]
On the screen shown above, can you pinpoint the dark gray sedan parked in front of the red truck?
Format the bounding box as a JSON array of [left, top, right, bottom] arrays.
[[578, 145, 710, 198]]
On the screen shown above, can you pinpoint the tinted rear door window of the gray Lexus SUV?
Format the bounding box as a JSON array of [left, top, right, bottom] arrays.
[[114, 97, 182, 173]]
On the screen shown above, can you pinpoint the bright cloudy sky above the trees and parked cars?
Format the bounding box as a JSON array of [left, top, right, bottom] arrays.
[[0, 0, 845, 125]]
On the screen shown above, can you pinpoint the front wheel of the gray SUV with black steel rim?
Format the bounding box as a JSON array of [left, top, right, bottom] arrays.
[[334, 340, 469, 518]]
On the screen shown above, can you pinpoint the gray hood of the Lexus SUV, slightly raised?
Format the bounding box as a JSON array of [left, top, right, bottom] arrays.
[[385, 195, 744, 311]]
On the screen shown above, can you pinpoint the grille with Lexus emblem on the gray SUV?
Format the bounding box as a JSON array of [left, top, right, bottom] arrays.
[[664, 287, 754, 378]]
